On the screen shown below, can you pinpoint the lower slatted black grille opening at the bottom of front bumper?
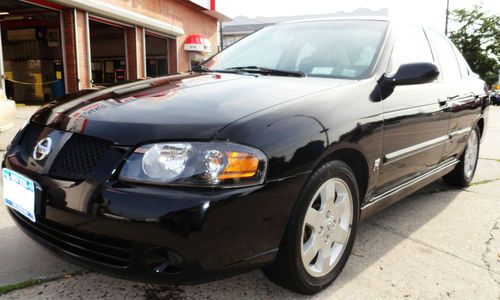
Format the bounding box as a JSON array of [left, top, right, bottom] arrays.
[[11, 210, 132, 268]]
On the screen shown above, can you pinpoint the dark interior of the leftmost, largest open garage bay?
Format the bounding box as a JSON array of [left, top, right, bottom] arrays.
[[0, 0, 65, 104]]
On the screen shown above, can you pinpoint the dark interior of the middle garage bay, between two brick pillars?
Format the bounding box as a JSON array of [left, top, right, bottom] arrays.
[[89, 19, 128, 86]]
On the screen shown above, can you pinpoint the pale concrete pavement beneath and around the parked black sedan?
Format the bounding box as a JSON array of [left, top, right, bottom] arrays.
[[0, 108, 500, 299]]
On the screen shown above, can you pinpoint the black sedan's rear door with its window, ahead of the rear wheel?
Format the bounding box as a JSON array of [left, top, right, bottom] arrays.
[[426, 30, 484, 158]]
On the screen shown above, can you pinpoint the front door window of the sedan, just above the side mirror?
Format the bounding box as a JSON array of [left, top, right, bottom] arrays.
[[388, 25, 434, 75]]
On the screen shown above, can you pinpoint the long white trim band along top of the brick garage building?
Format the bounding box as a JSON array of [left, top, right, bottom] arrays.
[[53, 0, 184, 37]]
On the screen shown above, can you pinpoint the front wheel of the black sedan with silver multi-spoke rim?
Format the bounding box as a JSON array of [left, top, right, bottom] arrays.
[[263, 161, 360, 295]]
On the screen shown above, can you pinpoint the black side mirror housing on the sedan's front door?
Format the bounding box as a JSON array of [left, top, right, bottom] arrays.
[[387, 63, 439, 86]]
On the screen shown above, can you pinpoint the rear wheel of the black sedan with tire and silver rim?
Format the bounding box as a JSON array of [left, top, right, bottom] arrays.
[[443, 125, 481, 187]]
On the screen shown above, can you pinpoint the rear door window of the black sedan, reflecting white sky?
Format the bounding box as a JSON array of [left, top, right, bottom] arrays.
[[428, 30, 461, 81]]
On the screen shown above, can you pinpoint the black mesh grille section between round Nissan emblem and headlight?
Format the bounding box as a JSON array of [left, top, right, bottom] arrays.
[[49, 134, 111, 178]]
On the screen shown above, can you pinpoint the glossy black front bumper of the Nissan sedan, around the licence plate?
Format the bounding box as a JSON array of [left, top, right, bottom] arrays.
[[3, 123, 306, 283]]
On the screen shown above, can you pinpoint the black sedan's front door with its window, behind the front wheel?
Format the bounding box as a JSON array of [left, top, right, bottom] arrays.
[[378, 26, 449, 193]]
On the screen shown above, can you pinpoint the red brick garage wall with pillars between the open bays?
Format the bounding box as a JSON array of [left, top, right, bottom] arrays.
[[62, 0, 218, 92]]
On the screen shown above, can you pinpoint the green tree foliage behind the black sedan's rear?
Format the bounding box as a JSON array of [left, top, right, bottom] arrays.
[[450, 5, 500, 85]]
